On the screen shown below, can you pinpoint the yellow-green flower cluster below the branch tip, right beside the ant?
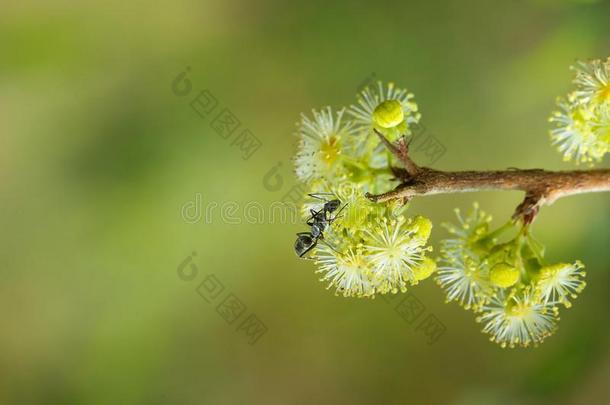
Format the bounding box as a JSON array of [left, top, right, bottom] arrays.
[[307, 184, 436, 297]]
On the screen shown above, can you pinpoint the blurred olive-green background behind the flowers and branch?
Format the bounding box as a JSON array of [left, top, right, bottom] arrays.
[[0, 0, 610, 404]]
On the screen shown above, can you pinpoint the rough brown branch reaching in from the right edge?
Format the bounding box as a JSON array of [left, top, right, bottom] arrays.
[[367, 168, 610, 223]]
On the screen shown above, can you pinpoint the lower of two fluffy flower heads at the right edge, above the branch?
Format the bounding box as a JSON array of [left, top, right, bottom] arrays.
[[549, 95, 608, 163]]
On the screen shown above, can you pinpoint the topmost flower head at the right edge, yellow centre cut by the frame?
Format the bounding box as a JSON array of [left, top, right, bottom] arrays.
[[571, 57, 610, 103]]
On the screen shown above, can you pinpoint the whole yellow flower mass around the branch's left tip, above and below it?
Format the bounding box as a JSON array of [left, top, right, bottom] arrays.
[[295, 82, 436, 297]]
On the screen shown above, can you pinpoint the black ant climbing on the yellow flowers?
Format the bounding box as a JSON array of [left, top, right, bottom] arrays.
[[294, 193, 347, 258]]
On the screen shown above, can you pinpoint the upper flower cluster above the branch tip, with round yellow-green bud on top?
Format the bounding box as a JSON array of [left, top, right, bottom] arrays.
[[295, 82, 420, 193]]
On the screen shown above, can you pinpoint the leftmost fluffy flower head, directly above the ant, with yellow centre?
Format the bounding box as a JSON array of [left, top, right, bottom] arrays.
[[295, 107, 353, 182]]
